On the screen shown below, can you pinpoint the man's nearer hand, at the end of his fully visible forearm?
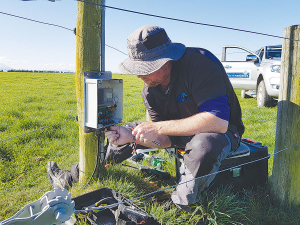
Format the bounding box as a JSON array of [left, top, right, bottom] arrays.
[[132, 122, 160, 143]]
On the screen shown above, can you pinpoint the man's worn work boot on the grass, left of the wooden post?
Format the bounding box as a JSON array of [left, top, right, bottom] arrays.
[[47, 161, 72, 189]]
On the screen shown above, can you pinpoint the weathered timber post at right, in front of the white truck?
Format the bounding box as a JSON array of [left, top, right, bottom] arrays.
[[271, 25, 300, 207]]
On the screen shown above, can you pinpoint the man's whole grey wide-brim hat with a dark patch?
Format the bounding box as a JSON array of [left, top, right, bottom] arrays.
[[119, 25, 186, 75]]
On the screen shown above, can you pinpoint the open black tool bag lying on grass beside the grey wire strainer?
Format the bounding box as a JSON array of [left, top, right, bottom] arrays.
[[73, 188, 160, 225]]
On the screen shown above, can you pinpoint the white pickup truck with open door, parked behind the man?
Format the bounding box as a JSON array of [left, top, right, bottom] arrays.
[[221, 45, 282, 107]]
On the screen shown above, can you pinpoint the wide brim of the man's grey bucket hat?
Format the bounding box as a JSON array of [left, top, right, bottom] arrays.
[[118, 43, 186, 75]]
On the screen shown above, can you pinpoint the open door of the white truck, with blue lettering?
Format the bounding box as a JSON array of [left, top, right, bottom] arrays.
[[222, 46, 260, 90]]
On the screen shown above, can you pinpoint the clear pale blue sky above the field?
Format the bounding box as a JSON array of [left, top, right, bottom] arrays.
[[0, 0, 300, 73]]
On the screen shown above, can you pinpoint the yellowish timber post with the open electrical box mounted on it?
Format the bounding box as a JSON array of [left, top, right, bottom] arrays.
[[76, 0, 102, 182]]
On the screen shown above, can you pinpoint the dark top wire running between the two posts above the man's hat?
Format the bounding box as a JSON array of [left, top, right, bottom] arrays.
[[77, 0, 300, 41]]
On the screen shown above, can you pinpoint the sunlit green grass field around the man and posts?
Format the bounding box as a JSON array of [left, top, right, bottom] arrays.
[[0, 73, 300, 225]]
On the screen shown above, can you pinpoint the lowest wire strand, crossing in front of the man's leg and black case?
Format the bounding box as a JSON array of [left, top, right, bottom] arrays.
[[74, 142, 300, 213]]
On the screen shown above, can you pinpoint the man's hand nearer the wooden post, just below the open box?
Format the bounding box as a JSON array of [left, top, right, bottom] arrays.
[[105, 126, 133, 145]]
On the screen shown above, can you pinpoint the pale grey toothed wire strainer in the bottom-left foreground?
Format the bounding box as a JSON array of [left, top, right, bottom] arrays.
[[0, 188, 75, 225]]
